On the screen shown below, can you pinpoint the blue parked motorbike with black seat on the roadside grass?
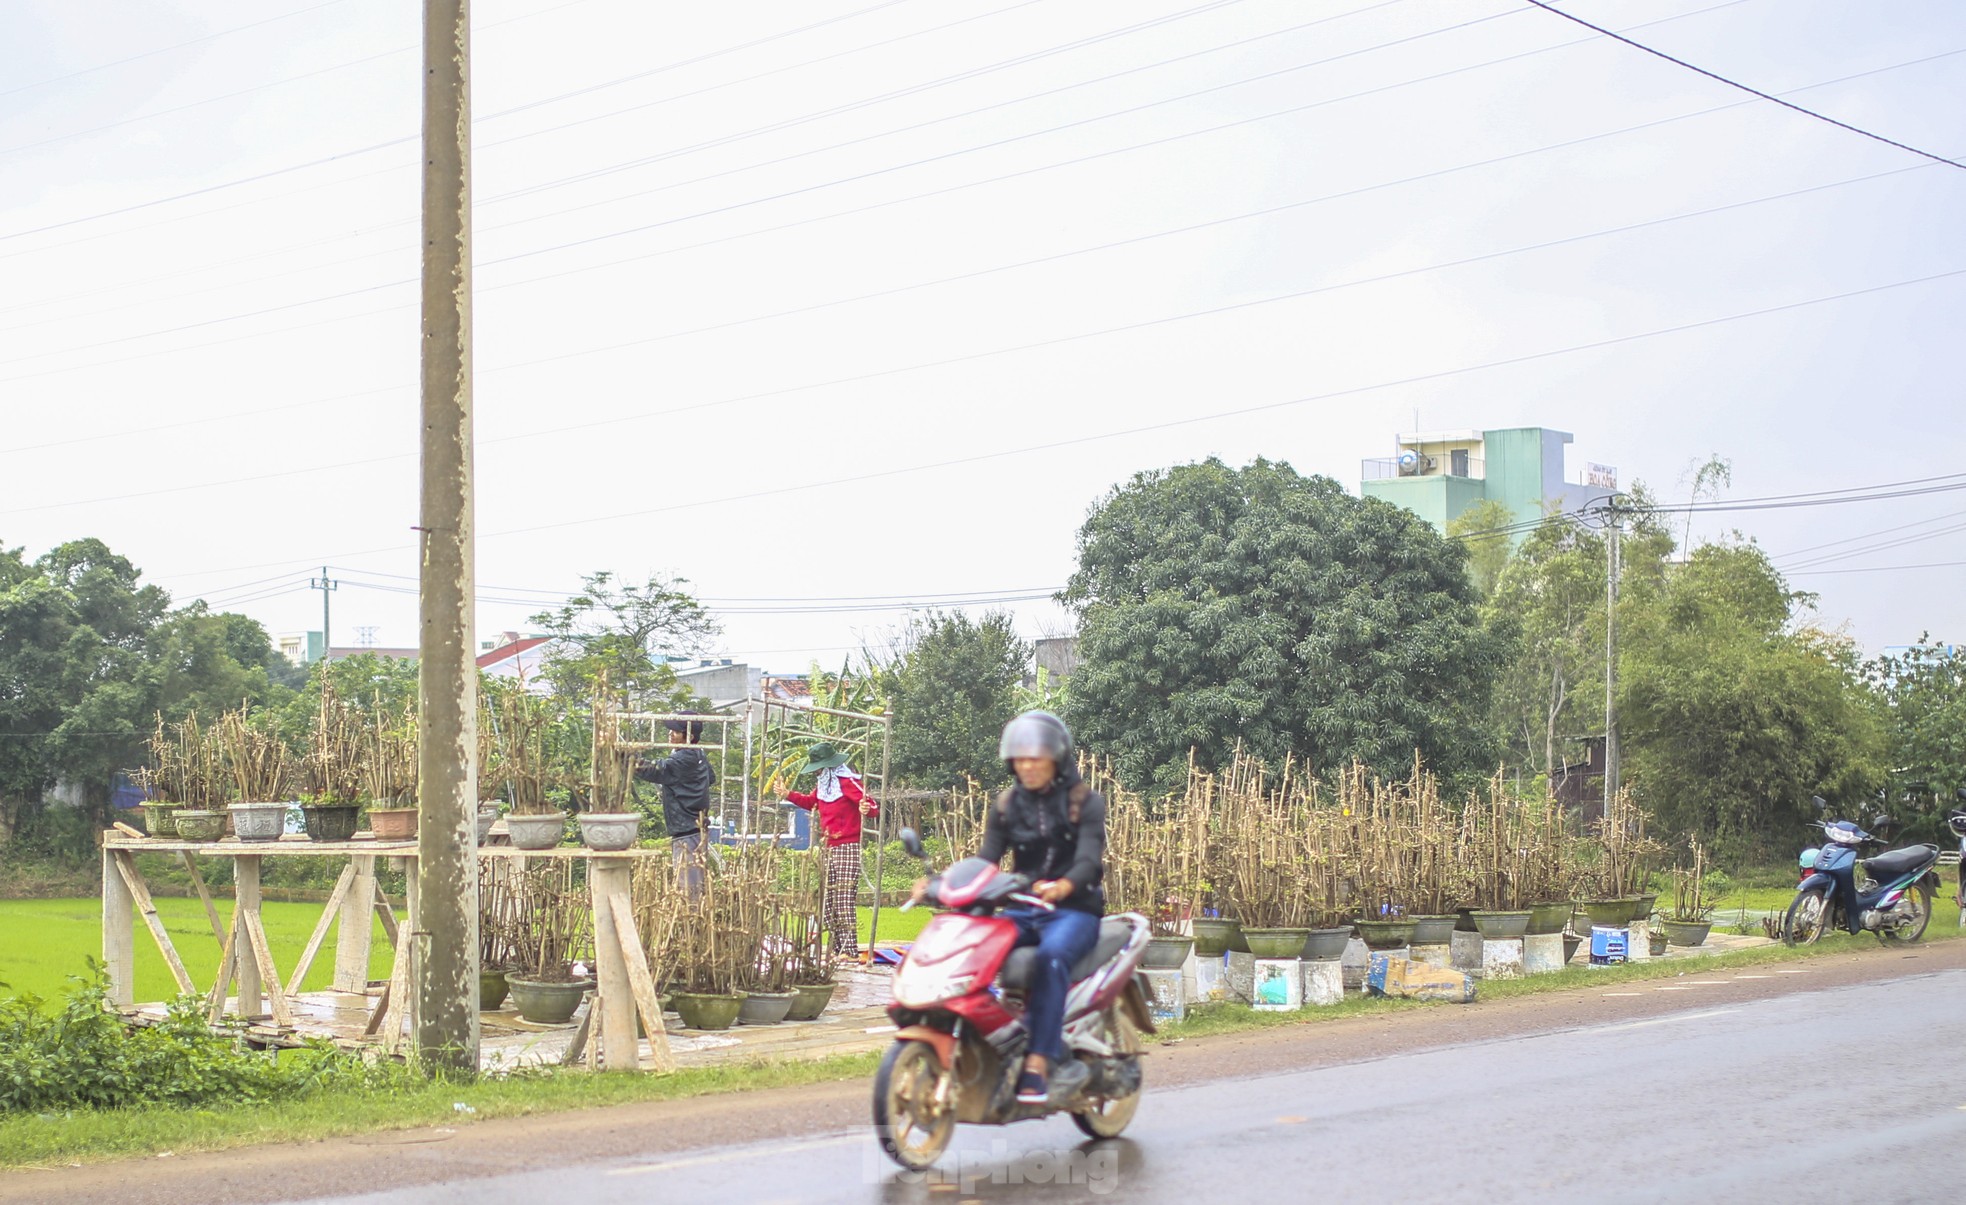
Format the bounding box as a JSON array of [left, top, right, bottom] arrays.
[[1781, 798, 1938, 946]]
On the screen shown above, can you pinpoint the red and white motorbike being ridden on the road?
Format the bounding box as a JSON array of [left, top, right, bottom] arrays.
[[873, 830, 1154, 1172]]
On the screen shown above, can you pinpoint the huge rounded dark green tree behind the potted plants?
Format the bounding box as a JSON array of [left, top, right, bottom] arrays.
[[1064, 460, 1500, 786]]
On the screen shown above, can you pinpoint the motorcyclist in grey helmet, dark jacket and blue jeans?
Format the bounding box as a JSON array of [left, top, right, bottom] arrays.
[[916, 712, 1105, 1105]]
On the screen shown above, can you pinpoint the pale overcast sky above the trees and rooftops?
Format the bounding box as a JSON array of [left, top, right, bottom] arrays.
[[0, 0, 1966, 670]]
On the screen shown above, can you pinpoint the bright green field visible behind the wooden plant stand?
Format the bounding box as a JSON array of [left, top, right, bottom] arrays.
[[0, 898, 389, 1001]]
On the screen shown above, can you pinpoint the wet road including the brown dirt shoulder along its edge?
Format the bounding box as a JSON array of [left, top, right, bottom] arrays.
[[15, 942, 1966, 1205]]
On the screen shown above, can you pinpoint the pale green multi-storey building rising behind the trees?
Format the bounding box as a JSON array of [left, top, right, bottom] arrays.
[[1359, 427, 1618, 543]]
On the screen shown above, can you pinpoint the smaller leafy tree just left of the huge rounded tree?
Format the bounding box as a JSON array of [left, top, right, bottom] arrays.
[[881, 611, 1030, 788]]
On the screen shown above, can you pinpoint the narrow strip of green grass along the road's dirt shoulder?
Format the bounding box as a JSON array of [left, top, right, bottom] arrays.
[[0, 904, 1962, 1168]]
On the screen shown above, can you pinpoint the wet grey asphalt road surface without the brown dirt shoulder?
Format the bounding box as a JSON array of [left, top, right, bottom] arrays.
[[294, 969, 1966, 1205]]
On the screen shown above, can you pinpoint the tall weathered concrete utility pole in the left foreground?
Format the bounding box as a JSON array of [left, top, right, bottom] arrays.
[[411, 0, 478, 1071]]
